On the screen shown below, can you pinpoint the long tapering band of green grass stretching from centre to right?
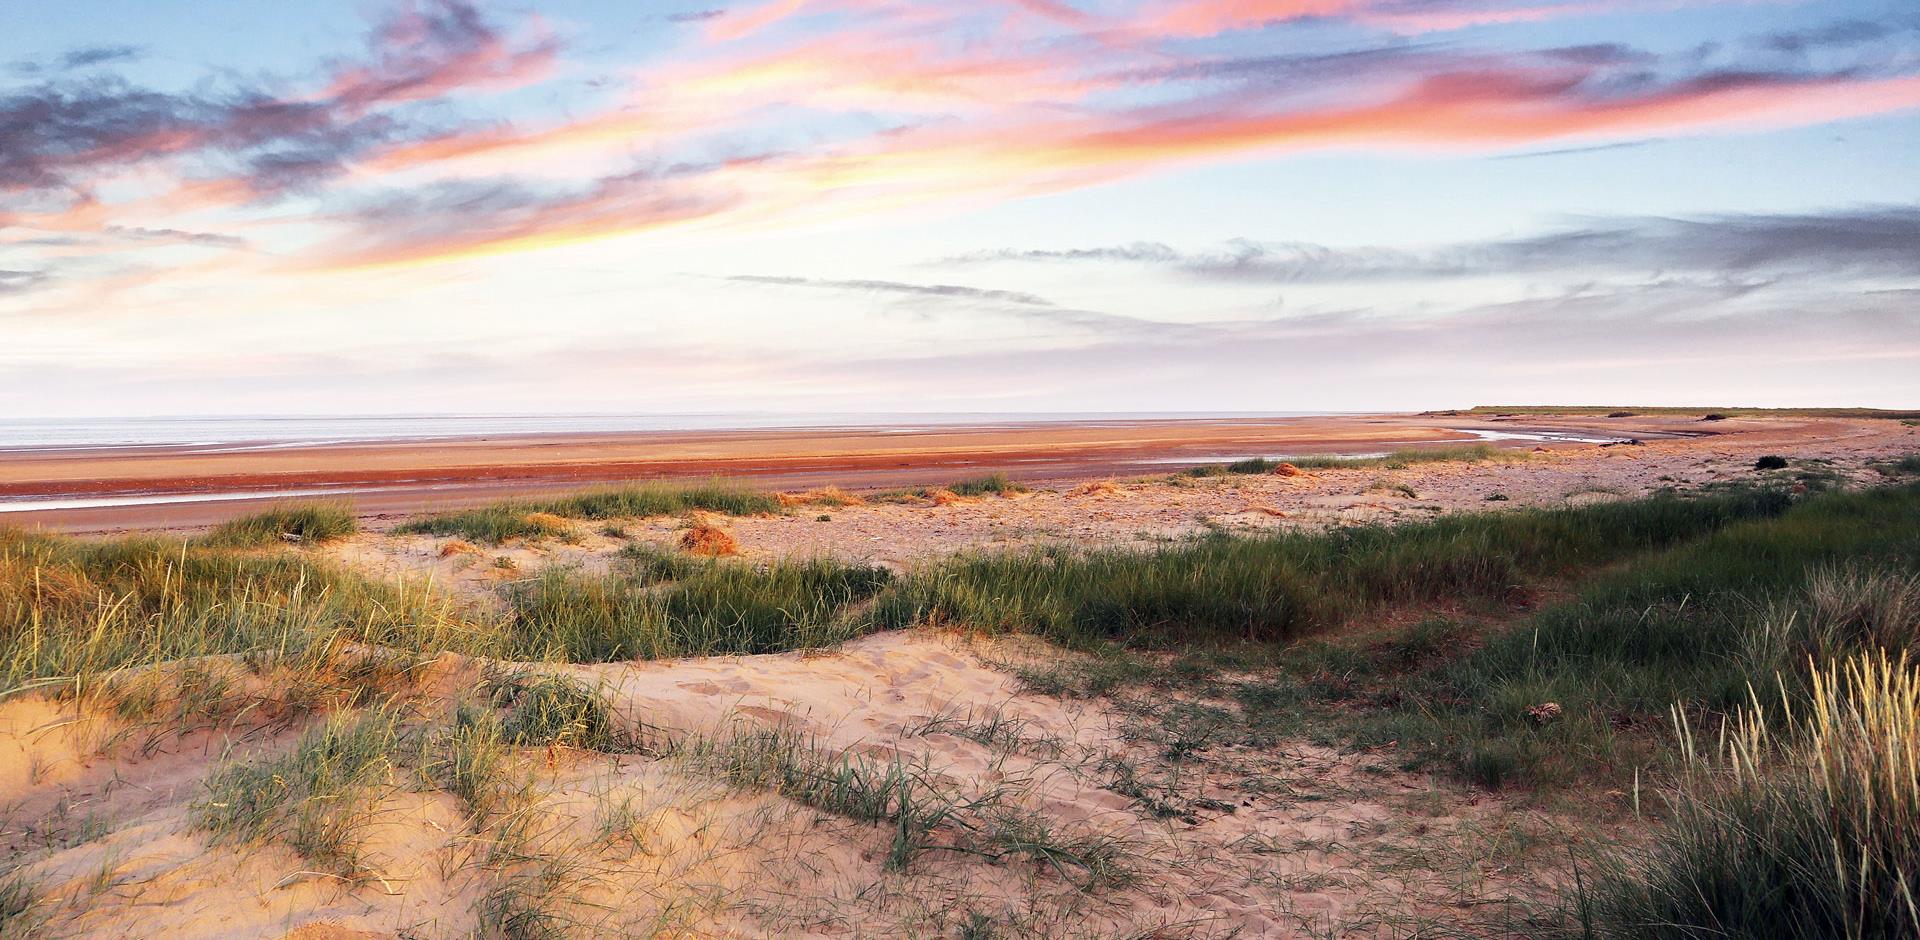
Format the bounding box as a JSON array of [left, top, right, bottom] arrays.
[[872, 489, 1788, 646]]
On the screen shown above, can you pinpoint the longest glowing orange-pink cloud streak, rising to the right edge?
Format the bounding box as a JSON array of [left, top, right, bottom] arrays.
[[318, 71, 1920, 267]]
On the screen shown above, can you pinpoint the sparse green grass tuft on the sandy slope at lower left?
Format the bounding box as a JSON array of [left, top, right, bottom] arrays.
[[190, 710, 405, 877]]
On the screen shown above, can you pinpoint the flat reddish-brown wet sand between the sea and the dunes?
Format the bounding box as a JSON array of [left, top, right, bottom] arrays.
[[0, 414, 1715, 531]]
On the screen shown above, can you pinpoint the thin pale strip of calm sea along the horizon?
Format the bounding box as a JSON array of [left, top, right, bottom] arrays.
[[0, 411, 1325, 451]]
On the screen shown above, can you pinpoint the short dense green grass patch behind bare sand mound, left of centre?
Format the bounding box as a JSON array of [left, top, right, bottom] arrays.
[[509, 551, 891, 662]]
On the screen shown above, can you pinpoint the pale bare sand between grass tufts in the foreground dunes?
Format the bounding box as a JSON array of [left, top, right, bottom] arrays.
[[0, 631, 1546, 940]]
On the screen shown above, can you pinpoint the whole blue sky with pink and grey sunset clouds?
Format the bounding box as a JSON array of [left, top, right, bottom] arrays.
[[0, 0, 1920, 418]]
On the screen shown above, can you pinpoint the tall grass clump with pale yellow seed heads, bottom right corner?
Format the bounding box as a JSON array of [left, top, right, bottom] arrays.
[[1563, 652, 1920, 940]]
